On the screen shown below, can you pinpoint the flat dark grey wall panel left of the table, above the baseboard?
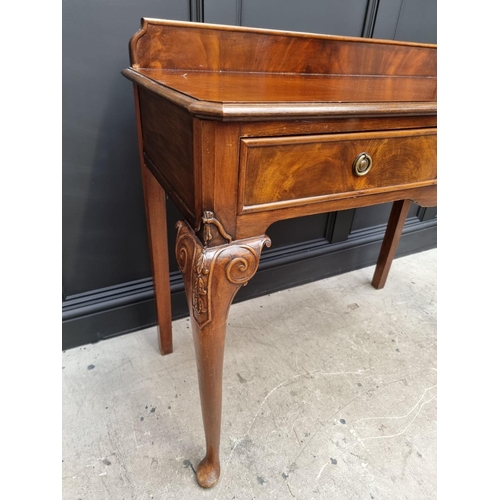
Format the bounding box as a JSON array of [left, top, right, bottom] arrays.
[[62, 0, 190, 296]]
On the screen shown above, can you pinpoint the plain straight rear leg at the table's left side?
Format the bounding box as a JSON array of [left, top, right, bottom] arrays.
[[134, 86, 173, 355]]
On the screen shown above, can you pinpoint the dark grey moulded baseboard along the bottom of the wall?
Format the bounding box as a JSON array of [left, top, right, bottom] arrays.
[[62, 219, 437, 350]]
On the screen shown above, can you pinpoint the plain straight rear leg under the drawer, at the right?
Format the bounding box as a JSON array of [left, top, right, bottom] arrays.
[[372, 200, 411, 290]]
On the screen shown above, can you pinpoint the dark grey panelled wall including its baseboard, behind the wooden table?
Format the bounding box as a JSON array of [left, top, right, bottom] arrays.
[[62, 0, 436, 348]]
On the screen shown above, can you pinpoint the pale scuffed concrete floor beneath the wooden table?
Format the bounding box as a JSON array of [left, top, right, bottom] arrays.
[[62, 250, 437, 500]]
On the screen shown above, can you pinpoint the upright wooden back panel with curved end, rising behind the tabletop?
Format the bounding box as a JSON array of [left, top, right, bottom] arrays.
[[130, 19, 437, 76]]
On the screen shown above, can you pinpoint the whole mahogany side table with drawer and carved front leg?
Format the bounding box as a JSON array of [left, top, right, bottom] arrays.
[[123, 19, 437, 487]]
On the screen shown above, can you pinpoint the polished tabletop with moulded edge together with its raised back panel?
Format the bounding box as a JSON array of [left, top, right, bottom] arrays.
[[123, 19, 437, 121]]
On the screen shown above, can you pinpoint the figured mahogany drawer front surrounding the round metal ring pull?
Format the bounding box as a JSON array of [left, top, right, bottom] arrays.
[[239, 128, 437, 212]]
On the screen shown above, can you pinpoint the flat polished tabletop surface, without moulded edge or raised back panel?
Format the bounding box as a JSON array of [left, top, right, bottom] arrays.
[[135, 68, 436, 103]]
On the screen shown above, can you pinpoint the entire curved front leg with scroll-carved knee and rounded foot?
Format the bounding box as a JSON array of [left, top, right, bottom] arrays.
[[175, 222, 271, 488]]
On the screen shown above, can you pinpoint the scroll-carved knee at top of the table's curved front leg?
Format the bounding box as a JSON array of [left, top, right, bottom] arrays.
[[175, 222, 271, 328]]
